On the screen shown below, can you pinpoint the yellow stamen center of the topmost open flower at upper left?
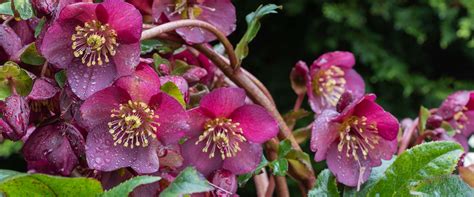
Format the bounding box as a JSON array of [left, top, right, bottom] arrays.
[[71, 20, 118, 66]]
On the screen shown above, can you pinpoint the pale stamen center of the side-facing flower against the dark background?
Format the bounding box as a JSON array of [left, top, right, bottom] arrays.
[[313, 66, 346, 106]]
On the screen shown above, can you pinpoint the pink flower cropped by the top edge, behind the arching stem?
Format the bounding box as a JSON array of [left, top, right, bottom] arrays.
[[153, 0, 236, 43]]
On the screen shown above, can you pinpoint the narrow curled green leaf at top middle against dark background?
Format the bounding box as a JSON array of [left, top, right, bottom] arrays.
[[235, 4, 283, 60]]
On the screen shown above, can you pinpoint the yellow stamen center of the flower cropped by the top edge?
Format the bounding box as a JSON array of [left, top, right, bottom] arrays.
[[170, 0, 216, 19]]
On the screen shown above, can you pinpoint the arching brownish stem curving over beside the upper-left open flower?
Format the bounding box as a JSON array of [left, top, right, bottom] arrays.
[[141, 19, 239, 68]]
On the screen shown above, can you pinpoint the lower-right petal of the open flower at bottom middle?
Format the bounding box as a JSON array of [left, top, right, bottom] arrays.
[[223, 142, 263, 175]]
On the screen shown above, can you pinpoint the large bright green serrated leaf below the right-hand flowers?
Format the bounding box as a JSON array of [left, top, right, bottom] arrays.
[[368, 141, 464, 196]]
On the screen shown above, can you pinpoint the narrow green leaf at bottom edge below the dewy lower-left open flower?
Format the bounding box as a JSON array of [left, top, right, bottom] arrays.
[[100, 176, 161, 197]]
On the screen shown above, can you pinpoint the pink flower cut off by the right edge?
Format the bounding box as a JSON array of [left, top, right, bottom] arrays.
[[433, 91, 474, 137]]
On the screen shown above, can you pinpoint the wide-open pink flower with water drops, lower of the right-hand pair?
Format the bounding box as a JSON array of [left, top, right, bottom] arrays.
[[311, 93, 399, 186]]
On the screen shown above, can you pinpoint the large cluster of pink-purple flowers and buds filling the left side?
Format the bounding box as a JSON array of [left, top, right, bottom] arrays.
[[0, 0, 278, 195]]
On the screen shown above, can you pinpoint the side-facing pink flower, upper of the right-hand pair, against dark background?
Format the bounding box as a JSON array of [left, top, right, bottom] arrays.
[[306, 51, 365, 114]]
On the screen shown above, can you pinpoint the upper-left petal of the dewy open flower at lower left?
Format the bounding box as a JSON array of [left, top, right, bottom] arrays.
[[80, 87, 131, 128]]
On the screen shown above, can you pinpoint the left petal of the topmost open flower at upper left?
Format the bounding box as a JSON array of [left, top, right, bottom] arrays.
[[40, 22, 75, 68]]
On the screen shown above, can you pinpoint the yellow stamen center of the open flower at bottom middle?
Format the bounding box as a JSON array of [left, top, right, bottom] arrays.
[[196, 118, 246, 159]]
